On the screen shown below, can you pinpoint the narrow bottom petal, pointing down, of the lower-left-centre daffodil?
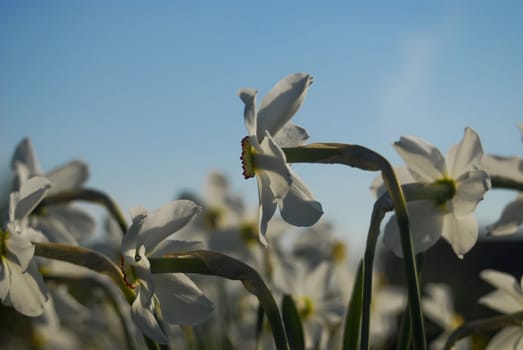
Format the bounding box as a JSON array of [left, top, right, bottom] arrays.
[[131, 289, 168, 344]]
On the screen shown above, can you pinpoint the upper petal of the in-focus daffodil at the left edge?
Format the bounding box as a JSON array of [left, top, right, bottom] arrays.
[[9, 176, 51, 221]]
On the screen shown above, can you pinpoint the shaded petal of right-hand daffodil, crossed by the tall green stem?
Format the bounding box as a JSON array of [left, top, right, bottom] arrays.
[[383, 201, 443, 257]]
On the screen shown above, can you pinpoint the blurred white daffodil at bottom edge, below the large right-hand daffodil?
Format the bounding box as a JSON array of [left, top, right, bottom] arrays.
[[422, 283, 470, 350]]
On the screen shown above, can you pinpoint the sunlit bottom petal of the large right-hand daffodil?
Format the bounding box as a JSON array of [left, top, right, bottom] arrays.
[[441, 213, 478, 258]]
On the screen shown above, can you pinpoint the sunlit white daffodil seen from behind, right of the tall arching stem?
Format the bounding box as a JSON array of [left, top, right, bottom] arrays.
[[383, 128, 490, 257]]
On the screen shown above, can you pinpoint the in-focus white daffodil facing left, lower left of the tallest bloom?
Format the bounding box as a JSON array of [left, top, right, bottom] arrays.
[[121, 200, 213, 344]]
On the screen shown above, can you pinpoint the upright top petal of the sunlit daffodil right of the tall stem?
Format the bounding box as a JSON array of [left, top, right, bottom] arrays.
[[447, 127, 483, 178]]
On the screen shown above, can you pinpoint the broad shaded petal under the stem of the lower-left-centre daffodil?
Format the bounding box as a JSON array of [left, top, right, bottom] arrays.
[[153, 274, 213, 325]]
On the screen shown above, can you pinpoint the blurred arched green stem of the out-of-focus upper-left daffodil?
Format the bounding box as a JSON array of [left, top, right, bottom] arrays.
[[37, 188, 129, 233]]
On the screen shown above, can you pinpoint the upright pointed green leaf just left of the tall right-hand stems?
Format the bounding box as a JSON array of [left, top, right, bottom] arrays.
[[343, 262, 363, 350]]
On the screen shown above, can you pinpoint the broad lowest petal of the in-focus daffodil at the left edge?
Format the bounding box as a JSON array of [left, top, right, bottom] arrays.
[[9, 261, 47, 316]]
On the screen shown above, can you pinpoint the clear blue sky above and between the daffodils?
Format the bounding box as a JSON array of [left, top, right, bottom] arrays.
[[0, 1, 523, 255]]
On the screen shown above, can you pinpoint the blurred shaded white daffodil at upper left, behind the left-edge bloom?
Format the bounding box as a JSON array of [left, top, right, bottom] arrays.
[[11, 138, 95, 244]]
